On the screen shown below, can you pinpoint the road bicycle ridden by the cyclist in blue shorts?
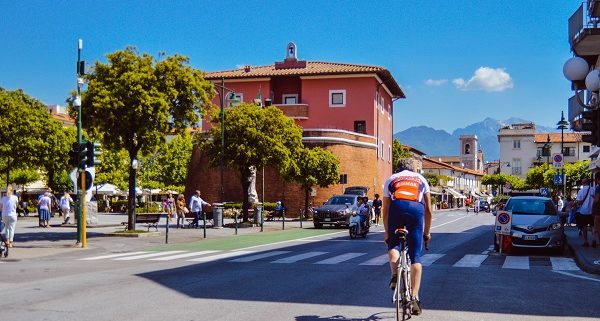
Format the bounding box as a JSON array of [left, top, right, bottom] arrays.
[[392, 228, 412, 321]]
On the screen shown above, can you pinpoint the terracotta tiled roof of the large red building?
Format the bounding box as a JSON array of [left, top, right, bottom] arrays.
[[204, 61, 405, 98]]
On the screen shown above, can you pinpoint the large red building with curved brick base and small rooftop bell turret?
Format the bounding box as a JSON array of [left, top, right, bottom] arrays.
[[187, 43, 405, 212]]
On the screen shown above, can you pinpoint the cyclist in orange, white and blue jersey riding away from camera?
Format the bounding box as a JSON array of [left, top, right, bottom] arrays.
[[382, 158, 431, 315]]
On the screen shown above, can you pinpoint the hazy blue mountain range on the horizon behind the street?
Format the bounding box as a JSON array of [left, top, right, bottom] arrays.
[[394, 117, 557, 161]]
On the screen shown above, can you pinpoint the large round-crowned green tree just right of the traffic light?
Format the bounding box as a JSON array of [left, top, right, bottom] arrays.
[[76, 47, 214, 230]]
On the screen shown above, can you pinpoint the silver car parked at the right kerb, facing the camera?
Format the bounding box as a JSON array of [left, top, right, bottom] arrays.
[[494, 196, 565, 253]]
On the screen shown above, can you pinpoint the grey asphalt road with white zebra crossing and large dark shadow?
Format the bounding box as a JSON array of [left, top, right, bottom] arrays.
[[0, 211, 600, 321]]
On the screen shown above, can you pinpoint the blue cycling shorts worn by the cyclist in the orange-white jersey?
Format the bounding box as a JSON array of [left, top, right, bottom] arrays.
[[387, 200, 425, 263]]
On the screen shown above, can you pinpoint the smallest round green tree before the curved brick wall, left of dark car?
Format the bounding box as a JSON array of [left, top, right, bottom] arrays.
[[292, 147, 340, 213]]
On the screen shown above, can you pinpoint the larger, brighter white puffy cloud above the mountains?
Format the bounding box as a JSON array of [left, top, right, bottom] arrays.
[[452, 67, 513, 92]]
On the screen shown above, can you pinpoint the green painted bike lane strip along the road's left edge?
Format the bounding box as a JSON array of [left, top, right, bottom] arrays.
[[147, 228, 347, 251]]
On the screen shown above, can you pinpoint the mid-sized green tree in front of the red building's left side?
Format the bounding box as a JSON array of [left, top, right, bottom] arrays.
[[201, 103, 302, 221]]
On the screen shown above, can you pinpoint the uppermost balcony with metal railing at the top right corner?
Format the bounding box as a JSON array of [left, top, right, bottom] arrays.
[[569, 0, 600, 56]]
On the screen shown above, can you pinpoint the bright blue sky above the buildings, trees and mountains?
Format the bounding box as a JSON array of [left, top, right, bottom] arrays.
[[0, 0, 581, 132]]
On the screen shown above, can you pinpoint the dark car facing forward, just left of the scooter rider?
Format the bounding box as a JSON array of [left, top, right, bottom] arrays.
[[313, 194, 359, 228]]
